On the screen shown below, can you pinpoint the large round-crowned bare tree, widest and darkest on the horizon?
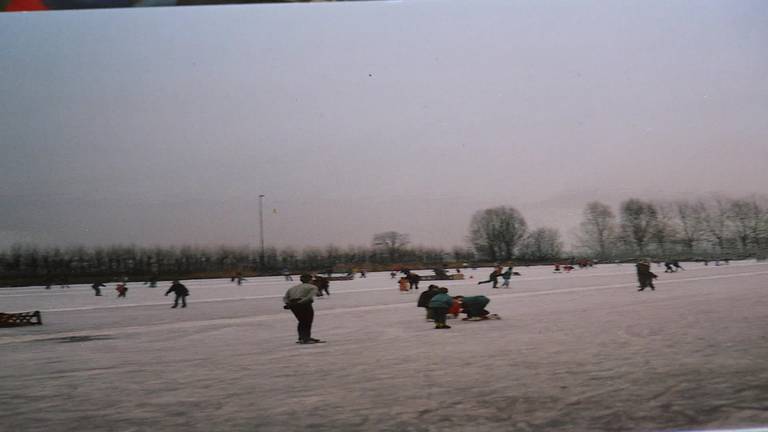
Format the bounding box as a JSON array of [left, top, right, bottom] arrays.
[[469, 206, 528, 261]]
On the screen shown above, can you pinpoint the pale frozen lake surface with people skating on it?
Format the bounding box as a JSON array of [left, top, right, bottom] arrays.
[[0, 261, 768, 432]]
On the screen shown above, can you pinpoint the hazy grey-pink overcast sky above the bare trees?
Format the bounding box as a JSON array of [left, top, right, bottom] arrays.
[[0, 0, 768, 248]]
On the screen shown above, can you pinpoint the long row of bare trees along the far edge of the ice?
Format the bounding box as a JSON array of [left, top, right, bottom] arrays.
[[0, 193, 768, 283]]
